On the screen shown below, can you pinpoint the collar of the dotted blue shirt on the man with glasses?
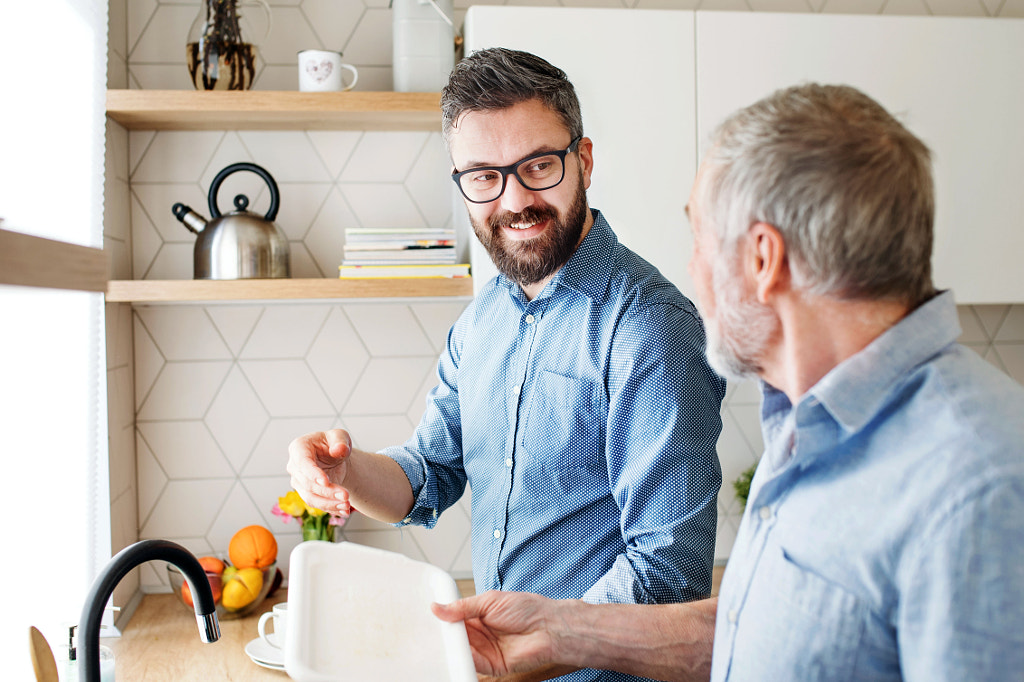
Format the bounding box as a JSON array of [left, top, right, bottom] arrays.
[[498, 209, 618, 302]]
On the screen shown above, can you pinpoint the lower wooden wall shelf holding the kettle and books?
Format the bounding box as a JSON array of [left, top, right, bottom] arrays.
[[106, 278, 473, 303]]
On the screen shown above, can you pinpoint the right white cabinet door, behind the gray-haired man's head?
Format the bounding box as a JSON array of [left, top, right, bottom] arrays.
[[696, 12, 1024, 303]]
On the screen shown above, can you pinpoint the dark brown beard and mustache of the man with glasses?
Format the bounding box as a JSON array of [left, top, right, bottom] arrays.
[[470, 182, 588, 287]]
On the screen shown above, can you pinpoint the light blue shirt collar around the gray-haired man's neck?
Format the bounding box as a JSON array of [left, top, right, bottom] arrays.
[[808, 291, 961, 432]]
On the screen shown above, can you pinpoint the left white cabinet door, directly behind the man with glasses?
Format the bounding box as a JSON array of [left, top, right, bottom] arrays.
[[466, 6, 696, 295]]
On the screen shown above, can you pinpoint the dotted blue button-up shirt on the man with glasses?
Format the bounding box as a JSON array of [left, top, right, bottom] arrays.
[[382, 211, 725, 680]]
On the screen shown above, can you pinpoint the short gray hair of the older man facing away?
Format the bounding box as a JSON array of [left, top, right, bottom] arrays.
[[699, 84, 935, 305]]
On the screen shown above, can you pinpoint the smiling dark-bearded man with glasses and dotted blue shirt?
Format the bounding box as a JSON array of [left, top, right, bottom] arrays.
[[288, 48, 725, 680]]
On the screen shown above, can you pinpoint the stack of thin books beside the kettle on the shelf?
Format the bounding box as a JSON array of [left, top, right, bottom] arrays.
[[338, 228, 469, 279]]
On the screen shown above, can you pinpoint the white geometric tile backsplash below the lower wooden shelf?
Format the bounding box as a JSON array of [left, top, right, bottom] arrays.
[[134, 300, 470, 587]]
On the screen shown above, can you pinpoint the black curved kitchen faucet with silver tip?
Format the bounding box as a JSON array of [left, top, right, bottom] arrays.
[[78, 540, 220, 682]]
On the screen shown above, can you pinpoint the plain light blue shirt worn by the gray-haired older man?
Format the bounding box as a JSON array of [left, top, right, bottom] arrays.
[[712, 292, 1024, 682]]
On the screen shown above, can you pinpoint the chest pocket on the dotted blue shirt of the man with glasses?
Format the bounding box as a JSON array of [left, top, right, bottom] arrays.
[[517, 371, 608, 469]]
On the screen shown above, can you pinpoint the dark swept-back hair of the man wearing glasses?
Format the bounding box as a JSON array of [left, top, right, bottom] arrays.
[[441, 47, 583, 150]]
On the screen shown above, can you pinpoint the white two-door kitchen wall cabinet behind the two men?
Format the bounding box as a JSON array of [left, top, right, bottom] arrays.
[[456, 6, 1024, 303]]
